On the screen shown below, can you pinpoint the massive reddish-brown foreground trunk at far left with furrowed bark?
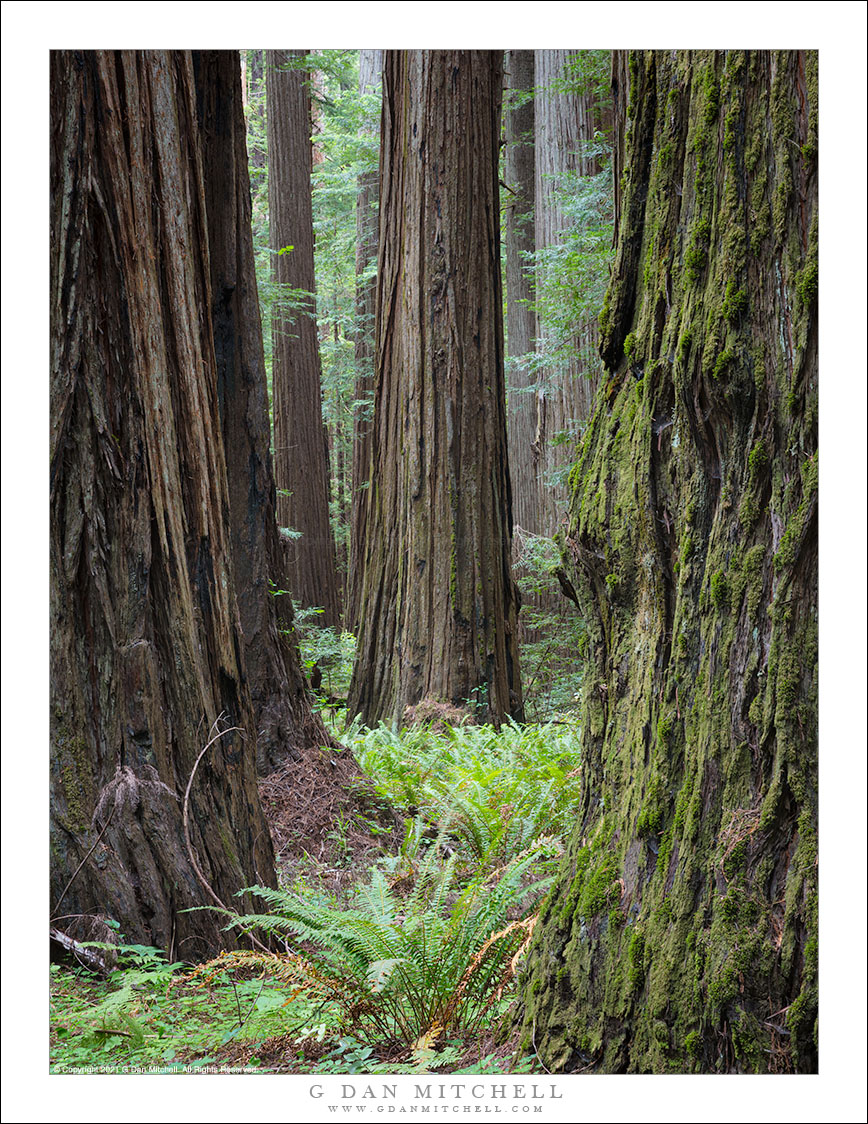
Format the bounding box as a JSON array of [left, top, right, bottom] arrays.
[[51, 51, 273, 958]]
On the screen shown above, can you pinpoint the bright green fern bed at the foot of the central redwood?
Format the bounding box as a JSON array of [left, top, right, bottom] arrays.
[[346, 722, 579, 868]]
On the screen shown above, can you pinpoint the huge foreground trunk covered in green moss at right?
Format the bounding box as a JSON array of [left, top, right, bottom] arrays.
[[524, 51, 819, 1073]]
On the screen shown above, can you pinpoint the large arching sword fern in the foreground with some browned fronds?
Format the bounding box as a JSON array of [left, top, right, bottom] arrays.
[[214, 837, 551, 1052]]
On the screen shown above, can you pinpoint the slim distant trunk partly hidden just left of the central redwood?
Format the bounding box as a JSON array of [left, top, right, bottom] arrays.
[[345, 51, 382, 632]]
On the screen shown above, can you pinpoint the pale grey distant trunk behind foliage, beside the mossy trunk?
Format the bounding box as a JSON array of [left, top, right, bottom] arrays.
[[527, 51, 599, 536]]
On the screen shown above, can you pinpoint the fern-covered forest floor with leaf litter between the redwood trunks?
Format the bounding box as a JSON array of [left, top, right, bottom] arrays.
[[51, 716, 578, 1073]]
